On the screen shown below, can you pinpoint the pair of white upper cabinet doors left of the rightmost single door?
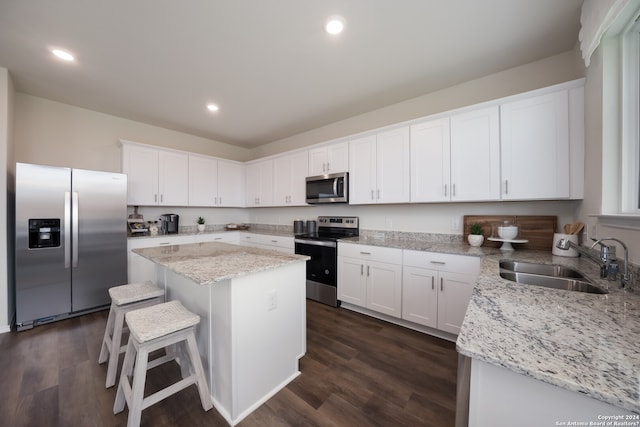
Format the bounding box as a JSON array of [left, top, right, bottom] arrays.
[[411, 107, 500, 202]]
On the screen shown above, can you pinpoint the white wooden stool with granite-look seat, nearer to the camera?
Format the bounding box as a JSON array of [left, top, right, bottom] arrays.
[[113, 301, 213, 427]]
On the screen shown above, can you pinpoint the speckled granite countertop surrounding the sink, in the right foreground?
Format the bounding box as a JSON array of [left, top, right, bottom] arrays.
[[457, 250, 640, 413]]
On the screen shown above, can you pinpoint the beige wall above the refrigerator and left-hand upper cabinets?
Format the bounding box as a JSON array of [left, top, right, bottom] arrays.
[[15, 93, 250, 172]]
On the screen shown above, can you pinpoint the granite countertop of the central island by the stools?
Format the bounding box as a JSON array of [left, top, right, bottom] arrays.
[[133, 242, 309, 285]]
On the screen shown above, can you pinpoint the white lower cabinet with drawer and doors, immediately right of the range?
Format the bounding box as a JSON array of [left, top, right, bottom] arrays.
[[338, 243, 402, 317]]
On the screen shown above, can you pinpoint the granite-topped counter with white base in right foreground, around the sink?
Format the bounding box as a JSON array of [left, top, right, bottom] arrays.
[[457, 250, 640, 427]]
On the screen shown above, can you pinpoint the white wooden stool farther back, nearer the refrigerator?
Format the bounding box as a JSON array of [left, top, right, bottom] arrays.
[[98, 282, 164, 388]]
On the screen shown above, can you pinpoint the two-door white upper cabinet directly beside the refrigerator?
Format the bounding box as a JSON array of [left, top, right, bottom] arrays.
[[122, 143, 189, 206]]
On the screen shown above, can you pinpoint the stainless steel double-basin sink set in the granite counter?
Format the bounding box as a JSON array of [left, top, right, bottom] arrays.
[[500, 260, 609, 294]]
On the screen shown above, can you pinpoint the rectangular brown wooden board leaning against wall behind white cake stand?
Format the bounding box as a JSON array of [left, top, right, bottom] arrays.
[[463, 215, 558, 251]]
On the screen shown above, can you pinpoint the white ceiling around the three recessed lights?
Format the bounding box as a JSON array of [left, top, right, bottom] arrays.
[[0, 0, 582, 148]]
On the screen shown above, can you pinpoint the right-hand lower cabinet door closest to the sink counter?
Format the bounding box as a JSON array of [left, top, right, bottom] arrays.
[[437, 271, 475, 334]]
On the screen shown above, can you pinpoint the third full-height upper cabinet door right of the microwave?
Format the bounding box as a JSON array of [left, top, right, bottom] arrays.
[[410, 117, 451, 202]]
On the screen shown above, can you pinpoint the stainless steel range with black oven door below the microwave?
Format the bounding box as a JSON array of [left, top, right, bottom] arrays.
[[294, 216, 360, 307]]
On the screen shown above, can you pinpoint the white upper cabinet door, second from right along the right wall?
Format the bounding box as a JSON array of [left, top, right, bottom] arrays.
[[451, 107, 500, 201]]
